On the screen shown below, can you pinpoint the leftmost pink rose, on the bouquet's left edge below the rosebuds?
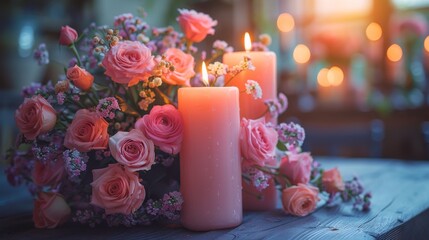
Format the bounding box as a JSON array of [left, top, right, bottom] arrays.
[[15, 95, 57, 140]]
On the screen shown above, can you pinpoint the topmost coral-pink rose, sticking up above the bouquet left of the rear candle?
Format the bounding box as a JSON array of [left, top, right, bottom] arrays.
[[177, 9, 217, 42]]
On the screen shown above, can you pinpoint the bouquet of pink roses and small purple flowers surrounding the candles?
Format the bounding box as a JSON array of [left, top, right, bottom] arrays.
[[6, 7, 370, 228]]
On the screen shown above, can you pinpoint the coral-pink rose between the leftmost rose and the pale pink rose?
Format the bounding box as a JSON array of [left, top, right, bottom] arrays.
[[64, 109, 109, 152]]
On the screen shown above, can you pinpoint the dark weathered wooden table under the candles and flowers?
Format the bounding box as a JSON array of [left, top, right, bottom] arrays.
[[0, 158, 429, 240]]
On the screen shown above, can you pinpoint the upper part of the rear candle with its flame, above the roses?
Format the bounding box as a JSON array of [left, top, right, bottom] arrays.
[[223, 33, 277, 124]]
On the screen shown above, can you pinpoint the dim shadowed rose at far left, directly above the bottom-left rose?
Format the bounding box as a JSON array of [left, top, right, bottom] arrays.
[[33, 159, 65, 187]]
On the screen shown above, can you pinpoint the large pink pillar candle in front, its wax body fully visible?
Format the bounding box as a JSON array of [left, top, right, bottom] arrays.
[[179, 62, 243, 231]]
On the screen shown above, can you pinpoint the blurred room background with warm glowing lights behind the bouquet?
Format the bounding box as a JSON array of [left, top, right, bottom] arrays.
[[0, 0, 429, 160]]
